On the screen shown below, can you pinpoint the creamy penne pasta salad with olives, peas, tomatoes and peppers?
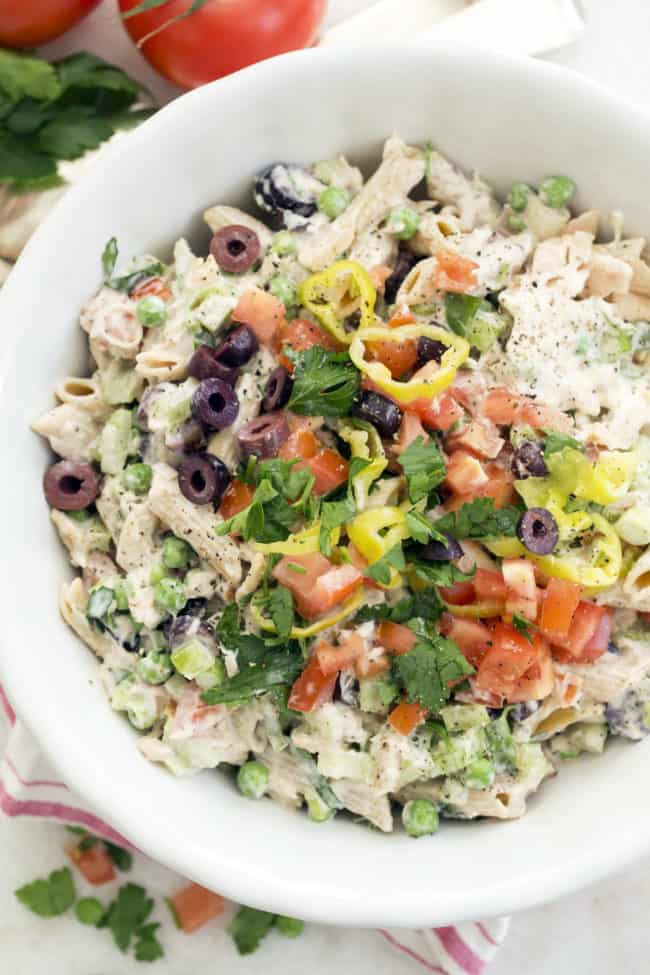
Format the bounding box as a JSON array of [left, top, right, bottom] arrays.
[[34, 137, 650, 836]]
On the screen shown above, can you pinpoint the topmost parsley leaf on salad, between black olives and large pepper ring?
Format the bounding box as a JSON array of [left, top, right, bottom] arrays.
[[287, 345, 360, 417]]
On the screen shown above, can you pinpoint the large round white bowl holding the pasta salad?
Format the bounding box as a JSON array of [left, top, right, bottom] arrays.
[[0, 46, 650, 927]]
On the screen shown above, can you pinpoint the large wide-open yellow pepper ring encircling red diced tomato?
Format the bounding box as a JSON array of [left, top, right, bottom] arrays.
[[350, 325, 470, 404]]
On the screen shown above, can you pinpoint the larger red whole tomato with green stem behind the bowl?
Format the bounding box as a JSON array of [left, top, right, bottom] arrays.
[[119, 0, 326, 88]]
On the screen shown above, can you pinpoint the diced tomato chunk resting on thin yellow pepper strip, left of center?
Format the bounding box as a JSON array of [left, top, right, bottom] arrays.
[[273, 552, 363, 620]]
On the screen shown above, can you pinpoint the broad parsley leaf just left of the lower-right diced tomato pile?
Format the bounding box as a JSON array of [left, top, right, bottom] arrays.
[[393, 636, 474, 714]]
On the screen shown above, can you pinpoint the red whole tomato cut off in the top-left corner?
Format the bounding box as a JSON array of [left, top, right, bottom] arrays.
[[0, 0, 101, 47]]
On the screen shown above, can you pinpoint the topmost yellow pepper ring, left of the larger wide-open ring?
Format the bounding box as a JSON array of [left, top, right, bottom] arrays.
[[298, 261, 377, 345]]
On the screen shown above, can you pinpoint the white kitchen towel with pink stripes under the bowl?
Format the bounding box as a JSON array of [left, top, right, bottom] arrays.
[[0, 685, 509, 975]]
